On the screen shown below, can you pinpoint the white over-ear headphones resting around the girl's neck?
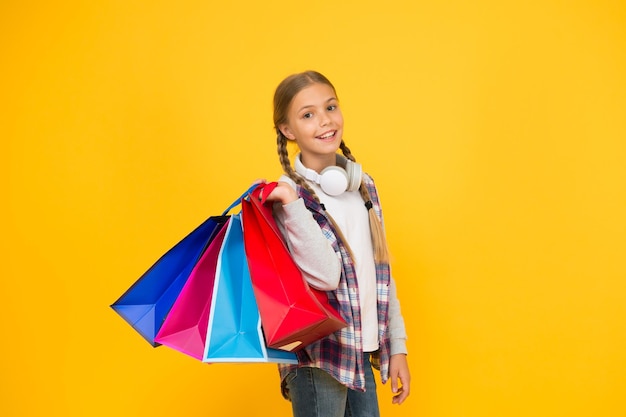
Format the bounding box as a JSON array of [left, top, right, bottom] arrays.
[[294, 154, 362, 196]]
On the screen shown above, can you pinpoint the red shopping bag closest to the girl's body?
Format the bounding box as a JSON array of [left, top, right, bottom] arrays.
[[242, 183, 347, 352]]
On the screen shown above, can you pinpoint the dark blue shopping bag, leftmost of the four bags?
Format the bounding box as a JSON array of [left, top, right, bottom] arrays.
[[111, 216, 227, 346]]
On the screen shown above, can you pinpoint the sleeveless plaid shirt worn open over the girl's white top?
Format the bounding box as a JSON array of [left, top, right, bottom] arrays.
[[278, 175, 391, 398]]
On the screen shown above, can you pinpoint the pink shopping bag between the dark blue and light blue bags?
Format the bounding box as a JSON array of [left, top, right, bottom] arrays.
[[155, 185, 256, 360]]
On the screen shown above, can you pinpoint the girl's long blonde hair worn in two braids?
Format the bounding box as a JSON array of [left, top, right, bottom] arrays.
[[274, 71, 389, 263]]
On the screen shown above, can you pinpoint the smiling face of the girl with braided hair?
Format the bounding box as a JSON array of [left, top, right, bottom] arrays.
[[279, 83, 343, 170]]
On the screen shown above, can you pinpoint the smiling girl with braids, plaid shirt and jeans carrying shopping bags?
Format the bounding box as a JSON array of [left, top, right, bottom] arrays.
[[268, 71, 410, 417]]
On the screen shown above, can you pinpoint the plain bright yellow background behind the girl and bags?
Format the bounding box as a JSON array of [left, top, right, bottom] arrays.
[[0, 0, 626, 417]]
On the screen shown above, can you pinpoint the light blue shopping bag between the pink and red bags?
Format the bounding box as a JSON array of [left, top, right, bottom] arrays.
[[202, 214, 298, 364]]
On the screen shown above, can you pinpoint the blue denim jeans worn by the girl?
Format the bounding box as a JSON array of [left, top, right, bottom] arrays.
[[285, 353, 380, 417]]
